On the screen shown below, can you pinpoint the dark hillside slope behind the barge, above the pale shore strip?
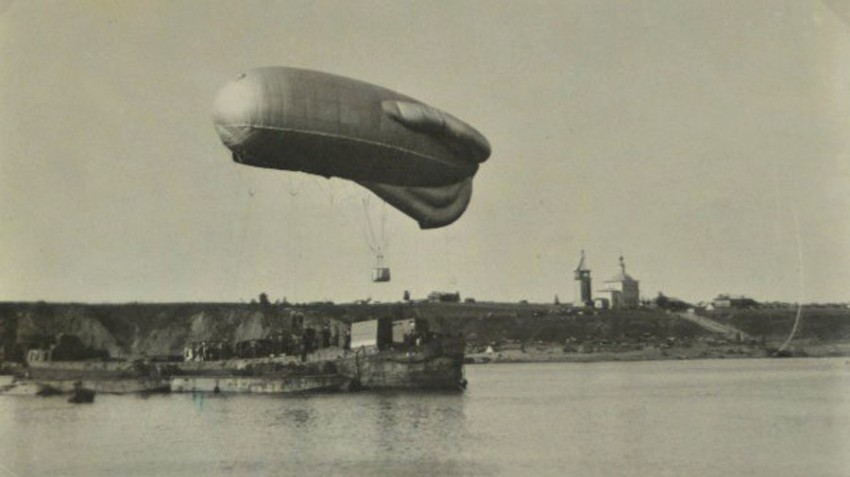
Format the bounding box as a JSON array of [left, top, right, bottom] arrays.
[[0, 302, 850, 359]]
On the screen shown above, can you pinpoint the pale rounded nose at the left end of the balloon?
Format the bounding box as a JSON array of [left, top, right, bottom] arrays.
[[213, 73, 261, 147]]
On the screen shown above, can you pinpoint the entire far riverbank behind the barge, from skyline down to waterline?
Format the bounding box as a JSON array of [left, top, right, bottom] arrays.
[[0, 302, 850, 363]]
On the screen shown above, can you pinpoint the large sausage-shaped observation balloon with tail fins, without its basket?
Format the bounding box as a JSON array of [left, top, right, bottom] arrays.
[[213, 67, 490, 229]]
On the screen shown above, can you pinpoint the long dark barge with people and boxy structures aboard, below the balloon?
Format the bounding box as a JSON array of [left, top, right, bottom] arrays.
[[0, 317, 466, 395]]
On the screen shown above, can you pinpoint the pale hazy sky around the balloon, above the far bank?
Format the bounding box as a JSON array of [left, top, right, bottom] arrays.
[[0, 0, 850, 302]]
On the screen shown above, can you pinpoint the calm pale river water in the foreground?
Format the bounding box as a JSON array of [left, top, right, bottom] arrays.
[[0, 358, 850, 477]]
